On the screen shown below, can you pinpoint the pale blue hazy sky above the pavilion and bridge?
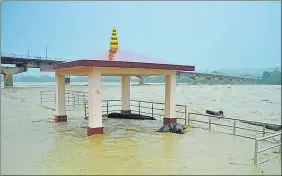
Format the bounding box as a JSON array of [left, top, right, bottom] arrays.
[[1, 1, 281, 73]]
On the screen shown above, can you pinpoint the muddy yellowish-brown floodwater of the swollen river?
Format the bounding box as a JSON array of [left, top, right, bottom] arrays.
[[1, 83, 281, 175]]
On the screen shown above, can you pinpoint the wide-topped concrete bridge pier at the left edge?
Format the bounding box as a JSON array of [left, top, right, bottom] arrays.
[[1, 66, 27, 87]]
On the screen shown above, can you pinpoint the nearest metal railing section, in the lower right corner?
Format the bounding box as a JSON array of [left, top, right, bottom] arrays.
[[254, 131, 281, 165]]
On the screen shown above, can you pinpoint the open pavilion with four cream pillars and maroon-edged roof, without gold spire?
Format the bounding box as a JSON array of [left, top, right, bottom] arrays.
[[40, 50, 195, 136]]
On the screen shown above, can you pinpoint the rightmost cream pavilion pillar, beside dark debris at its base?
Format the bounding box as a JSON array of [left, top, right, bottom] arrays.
[[164, 73, 177, 125]]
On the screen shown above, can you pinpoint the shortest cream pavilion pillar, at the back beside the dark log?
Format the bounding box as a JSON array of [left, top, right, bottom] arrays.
[[121, 75, 131, 114]]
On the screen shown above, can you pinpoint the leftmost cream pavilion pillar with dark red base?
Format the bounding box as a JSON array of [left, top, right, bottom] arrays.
[[55, 73, 67, 122]]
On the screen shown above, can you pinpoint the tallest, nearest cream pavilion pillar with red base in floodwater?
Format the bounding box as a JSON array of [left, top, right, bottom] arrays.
[[87, 68, 104, 136]]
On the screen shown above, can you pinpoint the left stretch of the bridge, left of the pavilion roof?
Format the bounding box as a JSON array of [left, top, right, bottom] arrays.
[[1, 53, 70, 87]]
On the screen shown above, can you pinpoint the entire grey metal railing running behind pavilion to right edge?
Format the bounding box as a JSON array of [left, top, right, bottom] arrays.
[[40, 90, 281, 165]]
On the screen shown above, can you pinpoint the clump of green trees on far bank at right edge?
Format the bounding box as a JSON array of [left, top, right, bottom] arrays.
[[262, 69, 281, 85]]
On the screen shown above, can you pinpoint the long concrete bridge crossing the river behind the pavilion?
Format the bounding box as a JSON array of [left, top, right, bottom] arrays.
[[1, 53, 261, 86]]
